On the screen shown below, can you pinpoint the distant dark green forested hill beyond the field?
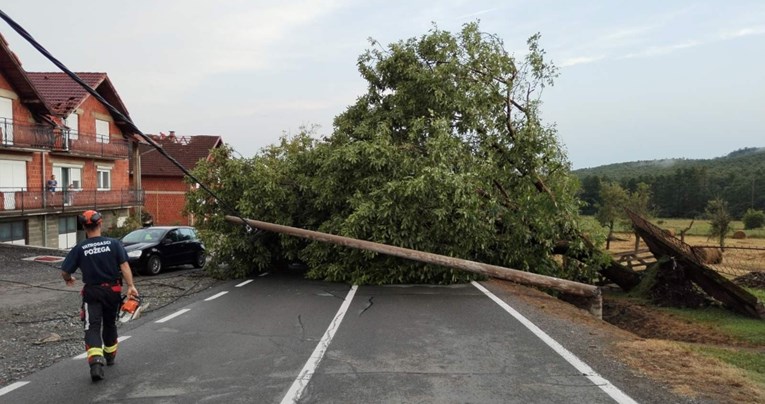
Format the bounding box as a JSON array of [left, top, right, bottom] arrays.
[[573, 147, 765, 218]]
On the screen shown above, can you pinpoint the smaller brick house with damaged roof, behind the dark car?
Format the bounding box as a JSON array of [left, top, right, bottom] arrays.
[[139, 131, 223, 225]]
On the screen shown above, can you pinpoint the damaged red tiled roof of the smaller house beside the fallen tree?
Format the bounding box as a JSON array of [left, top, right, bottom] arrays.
[[139, 135, 223, 177]]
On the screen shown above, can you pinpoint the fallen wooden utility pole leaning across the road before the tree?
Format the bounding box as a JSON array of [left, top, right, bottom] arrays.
[[226, 215, 603, 318]]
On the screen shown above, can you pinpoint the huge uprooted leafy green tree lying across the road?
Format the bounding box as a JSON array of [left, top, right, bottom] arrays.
[[187, 23, 616, 284]]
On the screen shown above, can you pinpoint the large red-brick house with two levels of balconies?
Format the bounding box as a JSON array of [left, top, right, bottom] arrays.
[[0, 36, 142, 248]]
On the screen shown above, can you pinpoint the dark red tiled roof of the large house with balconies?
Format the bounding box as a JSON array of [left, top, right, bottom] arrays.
[[27, 72, 106, 116]]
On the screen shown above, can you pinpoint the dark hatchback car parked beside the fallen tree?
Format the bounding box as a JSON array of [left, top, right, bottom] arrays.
[[122, 226, 207, 275]]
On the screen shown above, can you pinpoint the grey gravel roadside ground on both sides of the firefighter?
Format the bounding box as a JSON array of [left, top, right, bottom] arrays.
[[0, 244, 219, 387]]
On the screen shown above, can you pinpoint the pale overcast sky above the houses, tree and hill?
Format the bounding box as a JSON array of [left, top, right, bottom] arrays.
[[0, 0, 765, 168]]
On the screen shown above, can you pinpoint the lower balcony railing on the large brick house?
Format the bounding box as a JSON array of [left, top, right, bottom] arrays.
[[0, 188, 143, 215]]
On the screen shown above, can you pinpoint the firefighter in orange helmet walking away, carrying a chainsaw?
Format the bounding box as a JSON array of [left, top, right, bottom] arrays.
[[61, 210, 138, 382]]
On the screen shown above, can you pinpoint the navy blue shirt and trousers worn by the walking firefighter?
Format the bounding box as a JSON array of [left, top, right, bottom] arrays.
[[61, 236, 127, 363]]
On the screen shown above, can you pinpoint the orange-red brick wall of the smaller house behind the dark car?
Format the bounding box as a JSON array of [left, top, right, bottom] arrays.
[[141, 177, 193, 226]]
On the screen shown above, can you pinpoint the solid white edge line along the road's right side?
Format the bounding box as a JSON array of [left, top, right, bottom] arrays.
[[471, 281, 637, 404]]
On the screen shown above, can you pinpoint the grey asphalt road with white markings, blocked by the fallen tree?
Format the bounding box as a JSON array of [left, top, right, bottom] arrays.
[[0, 274, 668, 403]]
